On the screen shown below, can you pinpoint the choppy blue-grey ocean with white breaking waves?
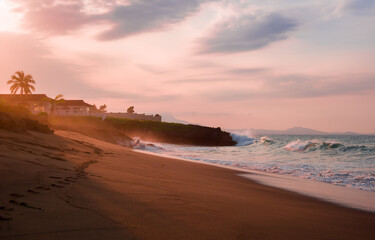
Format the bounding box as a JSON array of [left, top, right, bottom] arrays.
[[135, 133, 375, 192]]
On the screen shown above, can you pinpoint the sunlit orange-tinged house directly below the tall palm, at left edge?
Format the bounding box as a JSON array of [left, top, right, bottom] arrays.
[[0, 94, 51, 113]]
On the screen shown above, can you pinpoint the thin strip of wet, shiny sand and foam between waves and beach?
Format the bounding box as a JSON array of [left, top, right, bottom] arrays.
[[132, 149, 375, 213]]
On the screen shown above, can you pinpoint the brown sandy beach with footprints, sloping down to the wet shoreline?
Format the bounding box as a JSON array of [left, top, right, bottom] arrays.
[[0, 130, 375, 240]]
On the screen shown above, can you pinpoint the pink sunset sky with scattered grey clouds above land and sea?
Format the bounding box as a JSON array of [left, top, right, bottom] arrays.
[[0, 0, 375, 133]]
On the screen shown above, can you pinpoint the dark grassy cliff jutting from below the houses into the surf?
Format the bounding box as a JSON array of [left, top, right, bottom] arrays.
[[50, 116, 236, 146]]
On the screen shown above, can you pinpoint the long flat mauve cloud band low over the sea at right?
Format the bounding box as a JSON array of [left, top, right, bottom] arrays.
[[168, 72, 375, 102]]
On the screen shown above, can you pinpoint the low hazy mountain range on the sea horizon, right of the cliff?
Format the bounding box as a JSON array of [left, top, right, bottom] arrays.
[[228, 127, 358, 136]]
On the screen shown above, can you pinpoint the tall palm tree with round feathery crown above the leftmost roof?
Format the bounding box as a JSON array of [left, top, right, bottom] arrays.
[[7, 71, 35, 95]]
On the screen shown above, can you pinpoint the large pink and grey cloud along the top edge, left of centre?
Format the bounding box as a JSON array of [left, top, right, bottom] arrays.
[[13, 0, 214, 41]]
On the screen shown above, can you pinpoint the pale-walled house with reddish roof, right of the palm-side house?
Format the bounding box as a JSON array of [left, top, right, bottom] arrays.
[[53, 100, 96, 115]]
